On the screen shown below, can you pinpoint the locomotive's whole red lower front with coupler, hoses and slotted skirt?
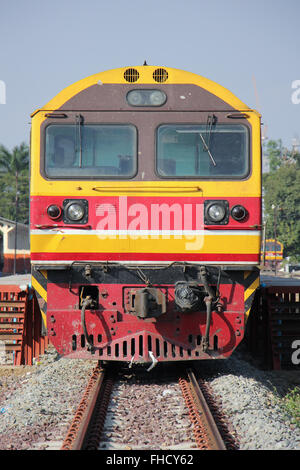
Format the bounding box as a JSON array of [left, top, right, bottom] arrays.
[[33, 263, 258, 363]]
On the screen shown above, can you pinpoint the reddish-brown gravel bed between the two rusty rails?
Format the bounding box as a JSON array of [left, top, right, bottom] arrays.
[[99, 370, 196, 450]]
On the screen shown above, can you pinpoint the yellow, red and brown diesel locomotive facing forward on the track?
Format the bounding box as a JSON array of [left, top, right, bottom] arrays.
[[30, 64, 261, 367]]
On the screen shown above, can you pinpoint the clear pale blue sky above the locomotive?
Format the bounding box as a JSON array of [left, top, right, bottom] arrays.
[[0, 0, 300, 149]]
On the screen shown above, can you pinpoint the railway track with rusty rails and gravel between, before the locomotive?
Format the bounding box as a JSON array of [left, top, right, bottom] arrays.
[[61, 363, 234, 450]]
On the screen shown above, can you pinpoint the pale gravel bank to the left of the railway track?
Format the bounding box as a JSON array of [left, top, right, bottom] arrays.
[[0, 349, 96, 449]]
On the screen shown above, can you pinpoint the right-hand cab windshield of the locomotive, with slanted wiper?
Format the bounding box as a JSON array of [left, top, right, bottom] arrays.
[[156, 124, 249, 179]]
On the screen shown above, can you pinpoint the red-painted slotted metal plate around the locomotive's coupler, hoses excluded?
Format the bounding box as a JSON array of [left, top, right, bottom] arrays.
[[47, 283, 244, 362]]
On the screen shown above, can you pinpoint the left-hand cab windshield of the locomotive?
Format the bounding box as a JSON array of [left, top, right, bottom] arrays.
[[45, 124, 137, 179]]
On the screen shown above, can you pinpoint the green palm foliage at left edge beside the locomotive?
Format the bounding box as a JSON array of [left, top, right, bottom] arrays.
[[0, 143, 29, 223]]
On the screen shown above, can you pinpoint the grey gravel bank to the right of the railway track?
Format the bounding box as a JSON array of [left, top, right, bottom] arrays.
[[197, 352, 300, 450]]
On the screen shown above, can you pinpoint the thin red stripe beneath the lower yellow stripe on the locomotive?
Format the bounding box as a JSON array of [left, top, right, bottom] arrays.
[[31, 253, 259, 263]]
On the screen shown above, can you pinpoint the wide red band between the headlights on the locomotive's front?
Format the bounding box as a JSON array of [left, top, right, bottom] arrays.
[[30, 195, 261, 230]]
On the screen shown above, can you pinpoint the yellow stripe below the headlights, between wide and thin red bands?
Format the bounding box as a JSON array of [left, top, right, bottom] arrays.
[[31, 233, 260, 254]]
